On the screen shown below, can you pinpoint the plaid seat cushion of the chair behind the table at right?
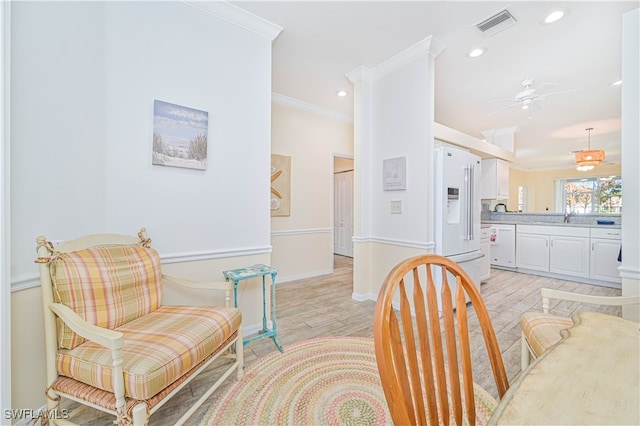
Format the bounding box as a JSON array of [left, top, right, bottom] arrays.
[[520, 312, 573, 356]]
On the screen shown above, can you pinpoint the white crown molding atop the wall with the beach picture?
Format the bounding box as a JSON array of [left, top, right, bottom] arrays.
[[183, 0, 283, 41]]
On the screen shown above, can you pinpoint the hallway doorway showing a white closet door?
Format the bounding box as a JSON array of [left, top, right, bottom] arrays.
[[333, 170, 353, 257]]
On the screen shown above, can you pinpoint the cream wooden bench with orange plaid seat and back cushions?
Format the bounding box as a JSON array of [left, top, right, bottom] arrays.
[[36, 228, 243, 425]]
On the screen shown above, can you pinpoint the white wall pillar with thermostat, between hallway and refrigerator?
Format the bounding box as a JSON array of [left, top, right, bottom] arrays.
[[348, 37, 443, 298]]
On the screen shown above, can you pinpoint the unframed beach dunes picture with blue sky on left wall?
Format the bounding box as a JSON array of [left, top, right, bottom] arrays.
[[152, 100, 209, 170]]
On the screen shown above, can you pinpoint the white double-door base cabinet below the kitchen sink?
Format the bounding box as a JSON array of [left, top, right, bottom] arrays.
[[516, 225, 589, 278]]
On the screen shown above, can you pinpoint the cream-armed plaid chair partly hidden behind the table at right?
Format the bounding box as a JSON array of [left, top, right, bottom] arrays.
[[520, 288, 640, 370]]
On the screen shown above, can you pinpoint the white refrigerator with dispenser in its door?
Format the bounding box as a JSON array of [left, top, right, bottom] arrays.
[[434, 146, 483, 291]]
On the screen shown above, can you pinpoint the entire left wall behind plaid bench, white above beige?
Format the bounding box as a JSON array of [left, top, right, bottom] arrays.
[[11, 2, 272, 408]]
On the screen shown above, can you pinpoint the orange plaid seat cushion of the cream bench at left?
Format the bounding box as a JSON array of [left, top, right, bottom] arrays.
[[56, 306, 242, 400]]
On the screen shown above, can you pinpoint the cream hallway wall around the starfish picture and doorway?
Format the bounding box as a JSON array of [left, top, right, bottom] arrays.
[[271, 95, 353, 282]]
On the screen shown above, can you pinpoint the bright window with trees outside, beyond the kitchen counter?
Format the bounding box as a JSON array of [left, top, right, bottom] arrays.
[[559, 176, 622, 214]]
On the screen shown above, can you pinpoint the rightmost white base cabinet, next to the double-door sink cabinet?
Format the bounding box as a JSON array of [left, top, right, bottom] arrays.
[[589, 229, 622, 283]]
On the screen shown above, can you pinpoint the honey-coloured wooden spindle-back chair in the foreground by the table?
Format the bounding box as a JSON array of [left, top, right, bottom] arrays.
[[374, 254, 509, 425]]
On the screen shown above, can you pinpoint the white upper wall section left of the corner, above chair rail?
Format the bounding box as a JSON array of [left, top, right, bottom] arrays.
[[11, 2, 108, 270]]
